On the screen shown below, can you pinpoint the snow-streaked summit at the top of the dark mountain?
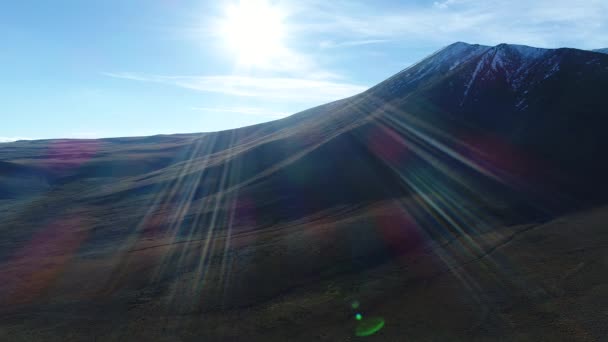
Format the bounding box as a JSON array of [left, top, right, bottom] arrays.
[[373, 42, 605, 109]]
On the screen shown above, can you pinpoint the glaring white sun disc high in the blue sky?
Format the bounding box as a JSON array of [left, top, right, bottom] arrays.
[[220, 0, 285, 65]]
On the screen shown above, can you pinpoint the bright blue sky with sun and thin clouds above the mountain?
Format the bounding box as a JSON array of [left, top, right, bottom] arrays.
[[0, 0, 608, 141]]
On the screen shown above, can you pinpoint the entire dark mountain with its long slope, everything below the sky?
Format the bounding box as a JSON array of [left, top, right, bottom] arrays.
[[0, 42, 608, 341]]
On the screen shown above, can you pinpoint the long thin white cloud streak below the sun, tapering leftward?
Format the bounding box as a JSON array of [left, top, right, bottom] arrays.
[[104, 72, 367, 102]]
